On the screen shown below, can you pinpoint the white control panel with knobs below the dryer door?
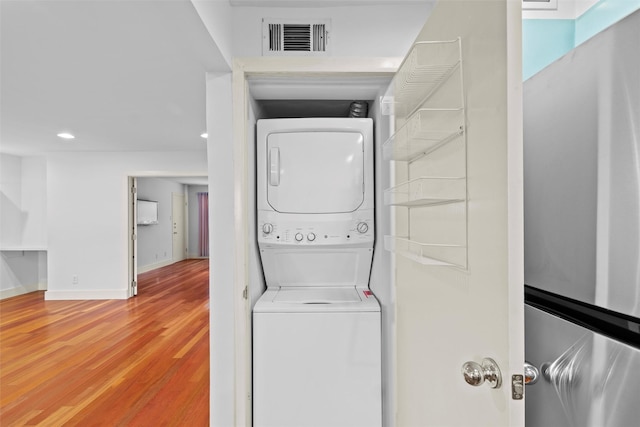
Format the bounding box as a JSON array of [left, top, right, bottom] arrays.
[[257, 213, 374, 246]]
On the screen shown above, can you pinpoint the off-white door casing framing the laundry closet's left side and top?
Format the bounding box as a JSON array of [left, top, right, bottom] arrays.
[[231, 57, 402, 427]]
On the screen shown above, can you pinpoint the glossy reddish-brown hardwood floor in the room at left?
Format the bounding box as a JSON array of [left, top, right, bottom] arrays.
[[0, 260, 209, 427]]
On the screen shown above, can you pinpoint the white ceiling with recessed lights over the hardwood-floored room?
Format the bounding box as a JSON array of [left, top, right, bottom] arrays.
[[0, 0, 226, 155]]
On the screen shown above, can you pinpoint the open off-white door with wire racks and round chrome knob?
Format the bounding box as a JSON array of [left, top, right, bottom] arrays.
[[390, 0, 524, 426]]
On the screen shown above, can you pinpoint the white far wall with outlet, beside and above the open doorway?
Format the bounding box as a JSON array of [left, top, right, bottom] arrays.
[[45, 151, 207, 299]]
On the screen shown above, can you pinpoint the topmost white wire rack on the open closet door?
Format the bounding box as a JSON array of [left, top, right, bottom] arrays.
[[394, 39, 461, 108]]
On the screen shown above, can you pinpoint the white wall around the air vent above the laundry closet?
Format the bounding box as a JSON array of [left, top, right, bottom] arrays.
[[233, 2, 431, 57]]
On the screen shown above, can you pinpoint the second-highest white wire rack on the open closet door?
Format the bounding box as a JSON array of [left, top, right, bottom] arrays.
[[382, 108, 464, 161]]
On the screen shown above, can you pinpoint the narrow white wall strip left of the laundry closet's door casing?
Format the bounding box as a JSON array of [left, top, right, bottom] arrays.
[[207, 73, 236, 427]]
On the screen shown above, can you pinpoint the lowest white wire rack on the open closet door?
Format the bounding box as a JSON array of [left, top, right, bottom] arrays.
[[384, 236, 467, 268]]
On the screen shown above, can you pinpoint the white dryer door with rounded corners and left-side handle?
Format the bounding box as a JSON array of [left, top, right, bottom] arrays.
[[266, 131, 364, 213]]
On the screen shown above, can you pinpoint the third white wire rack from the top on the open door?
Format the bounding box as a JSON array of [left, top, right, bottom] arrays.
[[384, 177, 467, 207]]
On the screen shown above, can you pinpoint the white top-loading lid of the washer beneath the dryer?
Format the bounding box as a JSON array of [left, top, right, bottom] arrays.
[[253, 287, 380, 313]]
